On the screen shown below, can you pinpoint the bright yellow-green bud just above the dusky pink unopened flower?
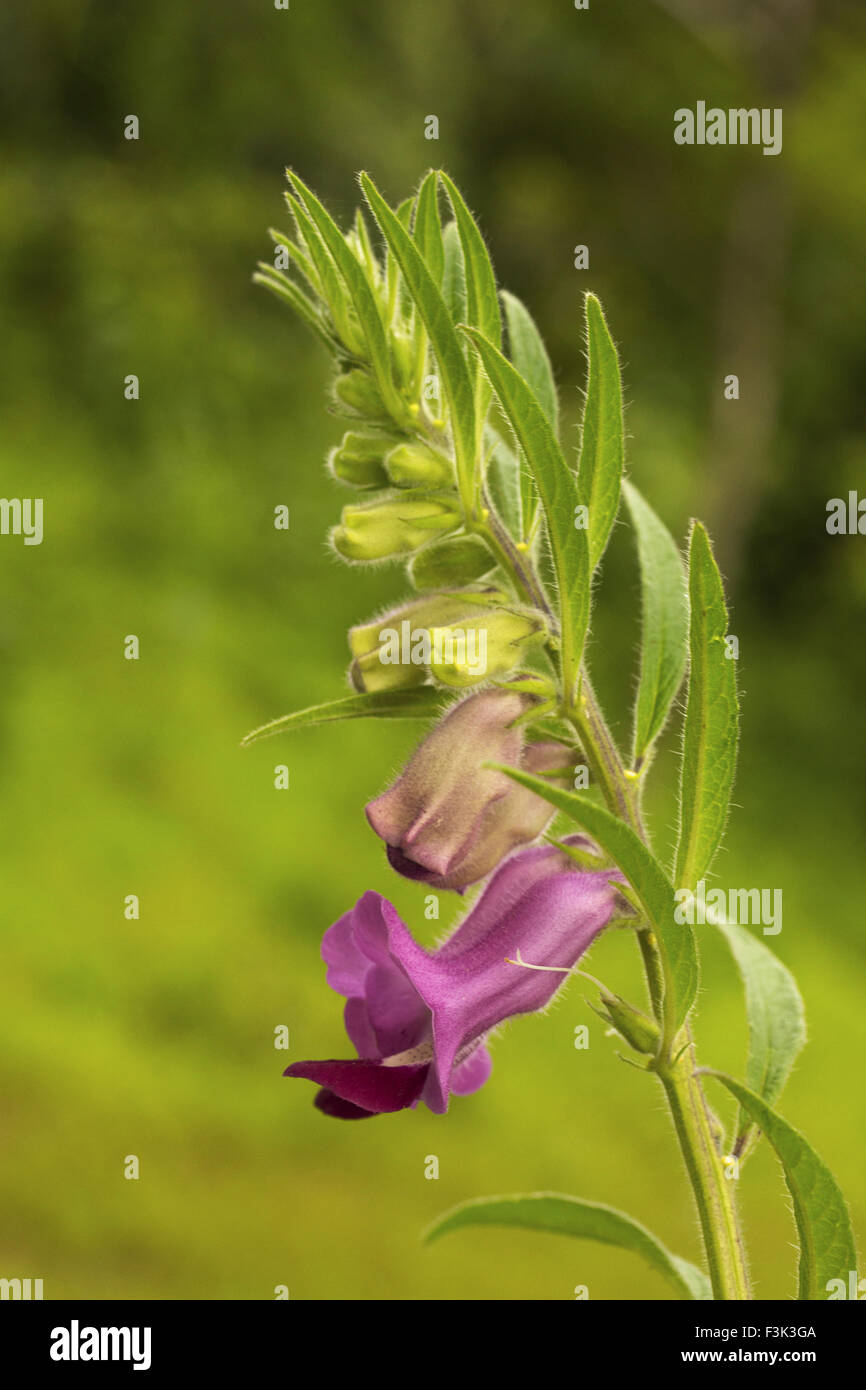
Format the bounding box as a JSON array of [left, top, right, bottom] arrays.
[[430, 607, 548, 689]]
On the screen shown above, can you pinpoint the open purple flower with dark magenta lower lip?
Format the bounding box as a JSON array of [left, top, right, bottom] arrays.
[[285, 835, 616, 1119]]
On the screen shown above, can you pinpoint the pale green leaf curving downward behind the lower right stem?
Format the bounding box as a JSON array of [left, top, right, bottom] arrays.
[[717, 922, 806, 1156]]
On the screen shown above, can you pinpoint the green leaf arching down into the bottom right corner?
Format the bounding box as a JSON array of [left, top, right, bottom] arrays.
[[703, 1069, 858, 1302]]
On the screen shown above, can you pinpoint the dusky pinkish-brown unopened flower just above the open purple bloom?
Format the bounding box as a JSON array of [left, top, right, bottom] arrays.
[[367, 689, 571, 892]]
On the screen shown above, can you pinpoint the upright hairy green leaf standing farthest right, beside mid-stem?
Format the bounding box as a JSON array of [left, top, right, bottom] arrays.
[[676, 521, 740, 888]]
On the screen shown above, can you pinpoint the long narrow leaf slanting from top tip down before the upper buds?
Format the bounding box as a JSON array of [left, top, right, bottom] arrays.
[[361, 174, 475, 510]]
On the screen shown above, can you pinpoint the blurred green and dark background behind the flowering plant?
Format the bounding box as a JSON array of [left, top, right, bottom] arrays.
[[0, 0, 866, 1298]]
